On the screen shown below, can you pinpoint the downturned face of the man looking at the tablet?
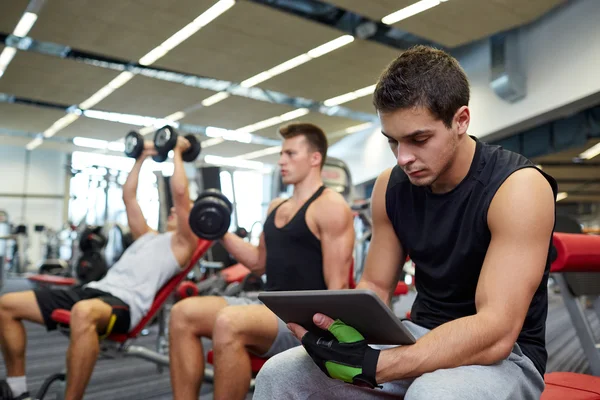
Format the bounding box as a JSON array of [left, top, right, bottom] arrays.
[[379, 107, 469, 186]]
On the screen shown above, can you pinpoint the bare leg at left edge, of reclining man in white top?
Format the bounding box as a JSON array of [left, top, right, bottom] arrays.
[[0, 290, 44, 377]]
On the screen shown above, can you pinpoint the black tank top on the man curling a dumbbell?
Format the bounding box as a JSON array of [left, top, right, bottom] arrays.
[[263, 186, 327, 291]]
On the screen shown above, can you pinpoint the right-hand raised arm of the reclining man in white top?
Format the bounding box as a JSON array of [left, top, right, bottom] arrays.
[[170, 137, 198, 266]]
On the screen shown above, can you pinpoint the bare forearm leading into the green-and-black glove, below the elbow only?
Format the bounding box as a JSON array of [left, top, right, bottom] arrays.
[[377, 314, 514, 383]]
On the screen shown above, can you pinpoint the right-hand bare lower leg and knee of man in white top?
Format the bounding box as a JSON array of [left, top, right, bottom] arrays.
[[65, 299, 112, 400]]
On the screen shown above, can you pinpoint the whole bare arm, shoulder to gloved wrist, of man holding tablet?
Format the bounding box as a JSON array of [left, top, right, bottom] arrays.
[[377, 168, 555, 383]]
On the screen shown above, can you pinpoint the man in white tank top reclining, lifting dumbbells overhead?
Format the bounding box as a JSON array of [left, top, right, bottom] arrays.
[[0, 136, 198, 400]]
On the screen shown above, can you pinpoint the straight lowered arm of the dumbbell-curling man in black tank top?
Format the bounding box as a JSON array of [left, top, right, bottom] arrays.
[[315, 193, 354, 289]]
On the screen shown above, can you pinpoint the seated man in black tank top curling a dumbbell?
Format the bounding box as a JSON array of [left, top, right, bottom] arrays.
[[169, 123, 354, 400]]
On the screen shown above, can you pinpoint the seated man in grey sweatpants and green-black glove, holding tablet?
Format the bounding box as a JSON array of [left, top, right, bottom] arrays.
[[254, 46, 557, 400]]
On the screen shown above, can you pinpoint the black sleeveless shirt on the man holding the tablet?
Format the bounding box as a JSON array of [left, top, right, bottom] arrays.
[[386, 138, 557, 376]]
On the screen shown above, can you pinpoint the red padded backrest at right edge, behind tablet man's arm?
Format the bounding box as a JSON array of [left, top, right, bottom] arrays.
[[550, 233, 600, 272]]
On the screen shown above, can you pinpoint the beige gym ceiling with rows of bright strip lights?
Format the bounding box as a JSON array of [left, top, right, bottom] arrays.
[[0, 0, 584, 192]]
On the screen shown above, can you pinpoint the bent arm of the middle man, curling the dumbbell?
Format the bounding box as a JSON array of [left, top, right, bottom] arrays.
[[221, 199, 282, 275]]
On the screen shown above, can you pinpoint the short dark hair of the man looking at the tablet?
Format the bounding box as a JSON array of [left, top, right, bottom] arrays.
[[373, 45, 470, 128]]
